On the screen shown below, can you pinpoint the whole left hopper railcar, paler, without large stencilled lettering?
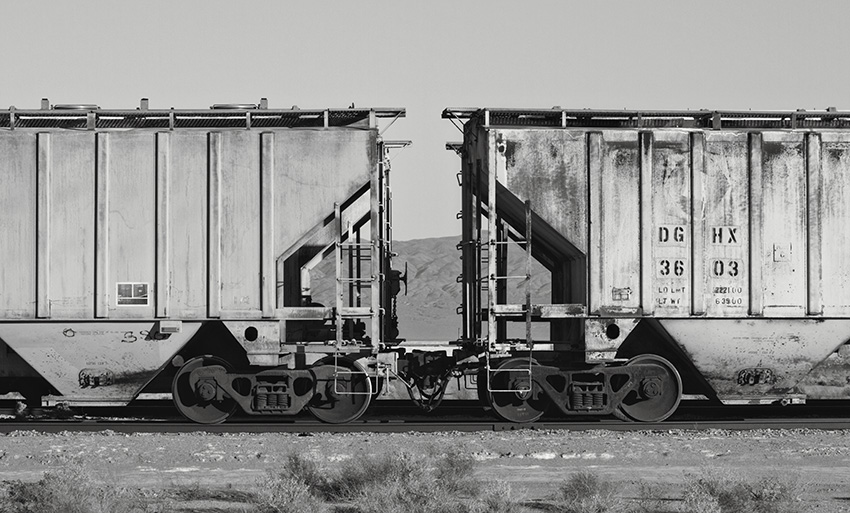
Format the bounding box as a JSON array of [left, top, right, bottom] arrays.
[[0, 100, 404, 423]]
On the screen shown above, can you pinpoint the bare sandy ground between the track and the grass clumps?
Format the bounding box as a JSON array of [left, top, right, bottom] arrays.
[[0, 430, 850, 513]]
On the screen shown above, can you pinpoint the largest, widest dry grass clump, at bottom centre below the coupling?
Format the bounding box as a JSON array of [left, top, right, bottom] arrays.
[[257, 452, 519, 513]]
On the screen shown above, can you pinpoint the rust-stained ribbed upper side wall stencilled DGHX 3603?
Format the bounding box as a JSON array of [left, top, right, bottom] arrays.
[[480, 123, 850, 317]]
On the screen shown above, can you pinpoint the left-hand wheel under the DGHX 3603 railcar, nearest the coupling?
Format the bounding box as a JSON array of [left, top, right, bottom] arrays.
[[479, 358, 549, 422]]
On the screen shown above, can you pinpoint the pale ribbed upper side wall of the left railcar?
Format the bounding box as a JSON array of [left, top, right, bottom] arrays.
[[0, 123, 378, 320]]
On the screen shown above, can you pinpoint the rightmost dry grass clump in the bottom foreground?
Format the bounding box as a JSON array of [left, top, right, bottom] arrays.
[[683, 471, 801, 513]]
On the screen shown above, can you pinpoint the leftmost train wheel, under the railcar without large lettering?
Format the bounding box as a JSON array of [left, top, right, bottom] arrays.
[[171, 356, 238, 424]]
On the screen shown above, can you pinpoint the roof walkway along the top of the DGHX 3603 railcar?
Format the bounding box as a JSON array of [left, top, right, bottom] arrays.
[[443, 107, 850, 129]]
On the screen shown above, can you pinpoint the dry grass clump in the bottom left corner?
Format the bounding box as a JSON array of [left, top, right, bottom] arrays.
[[0, 465, 151, 513]]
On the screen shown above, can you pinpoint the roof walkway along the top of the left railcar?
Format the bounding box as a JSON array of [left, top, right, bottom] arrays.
[[0, 100, 405, 130]]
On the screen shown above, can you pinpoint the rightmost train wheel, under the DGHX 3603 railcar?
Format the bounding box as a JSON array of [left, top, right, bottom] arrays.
[[614, 354, 682, 422]]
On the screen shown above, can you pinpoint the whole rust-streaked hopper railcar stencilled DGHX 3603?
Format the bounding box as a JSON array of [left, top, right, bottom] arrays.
[[443, 108, 850, 421]]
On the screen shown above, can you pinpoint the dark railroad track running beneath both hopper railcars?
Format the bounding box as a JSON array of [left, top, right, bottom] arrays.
[[0, 404, 850, 433]]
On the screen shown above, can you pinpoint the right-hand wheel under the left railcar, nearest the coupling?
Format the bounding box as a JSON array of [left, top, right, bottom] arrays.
[[307, 357, 372, 424]]
